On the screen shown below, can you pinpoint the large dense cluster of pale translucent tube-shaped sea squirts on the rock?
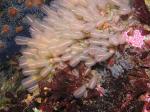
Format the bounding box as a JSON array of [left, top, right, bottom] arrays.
[[16, 0, 143, 96]]
